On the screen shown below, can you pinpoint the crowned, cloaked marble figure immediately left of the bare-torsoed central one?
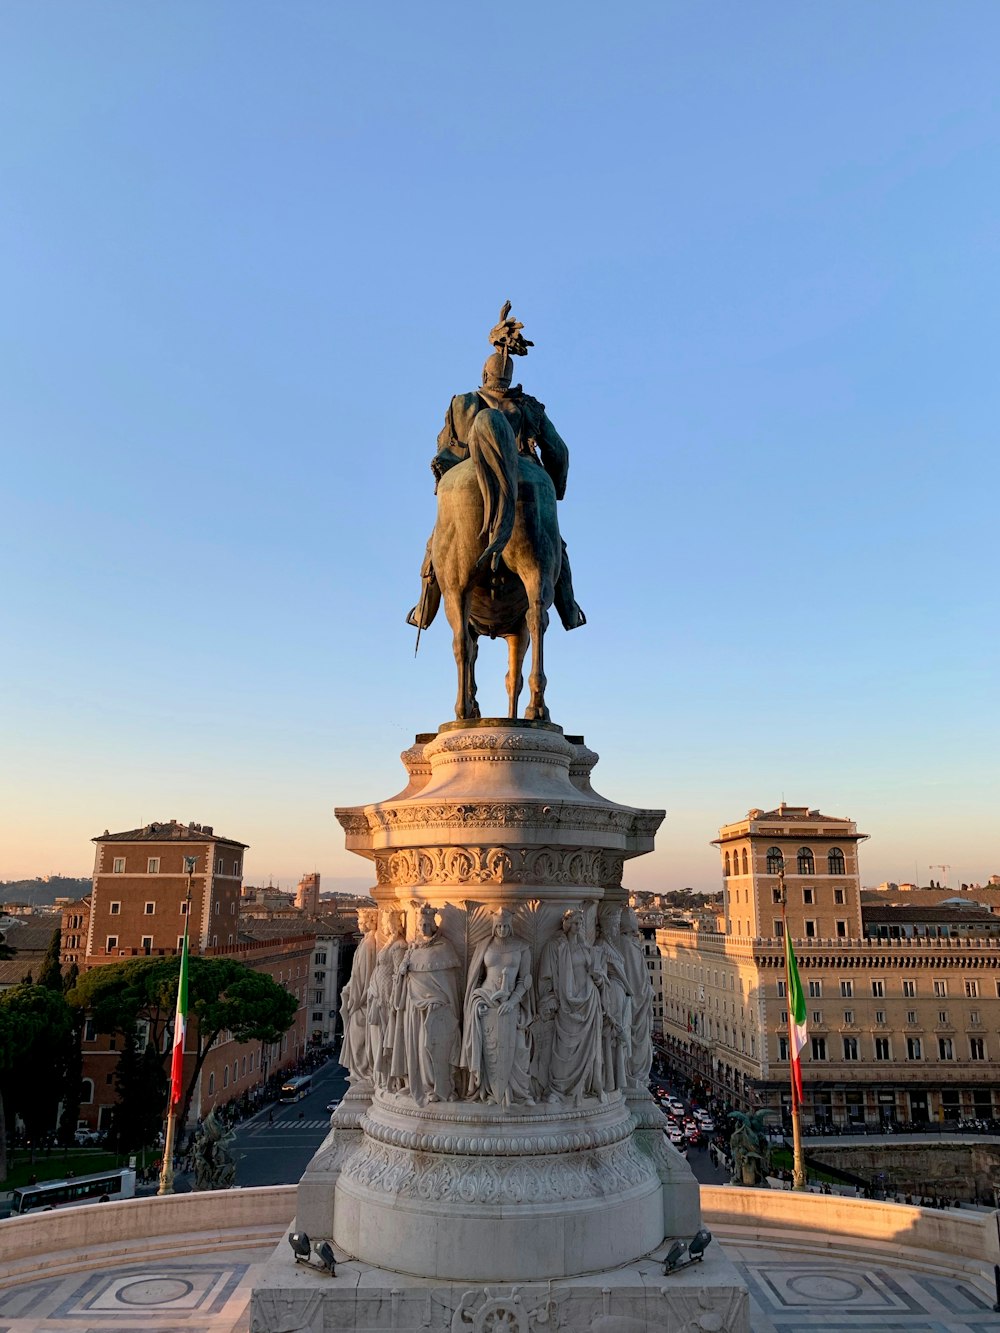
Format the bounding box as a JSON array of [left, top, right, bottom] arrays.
[[389, 905, 460, 1106]]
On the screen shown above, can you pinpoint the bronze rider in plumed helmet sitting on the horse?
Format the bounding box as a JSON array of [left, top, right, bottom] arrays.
[[407, 301, 587, 629]]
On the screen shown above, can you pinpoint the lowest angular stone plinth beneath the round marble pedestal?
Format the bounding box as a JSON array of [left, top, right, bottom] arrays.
[[251, 1241, 749, 1333]]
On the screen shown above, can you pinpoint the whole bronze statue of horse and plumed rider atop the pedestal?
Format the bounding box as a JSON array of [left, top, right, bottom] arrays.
[[407, 301, 587, 721]]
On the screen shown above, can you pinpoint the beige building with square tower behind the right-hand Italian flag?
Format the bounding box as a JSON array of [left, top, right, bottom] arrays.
[[656, 805, 1000, 1126]]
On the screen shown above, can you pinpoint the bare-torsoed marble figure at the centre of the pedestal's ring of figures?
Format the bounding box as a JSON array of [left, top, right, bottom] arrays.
[[461, 908, 535, 1106]]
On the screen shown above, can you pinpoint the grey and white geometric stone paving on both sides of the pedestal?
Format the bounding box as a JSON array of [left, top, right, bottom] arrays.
[[0, 1244, 1000, 1333]]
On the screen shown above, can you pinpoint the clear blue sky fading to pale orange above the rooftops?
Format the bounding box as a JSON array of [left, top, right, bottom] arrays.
[[0, 0, 1000, 890]]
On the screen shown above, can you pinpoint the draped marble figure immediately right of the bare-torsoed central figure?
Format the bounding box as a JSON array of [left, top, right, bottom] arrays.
[[539, 908, 607, 1102]]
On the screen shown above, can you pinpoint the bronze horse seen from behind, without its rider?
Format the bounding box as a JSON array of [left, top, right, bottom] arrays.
[[431, 408, 563, 721]]
